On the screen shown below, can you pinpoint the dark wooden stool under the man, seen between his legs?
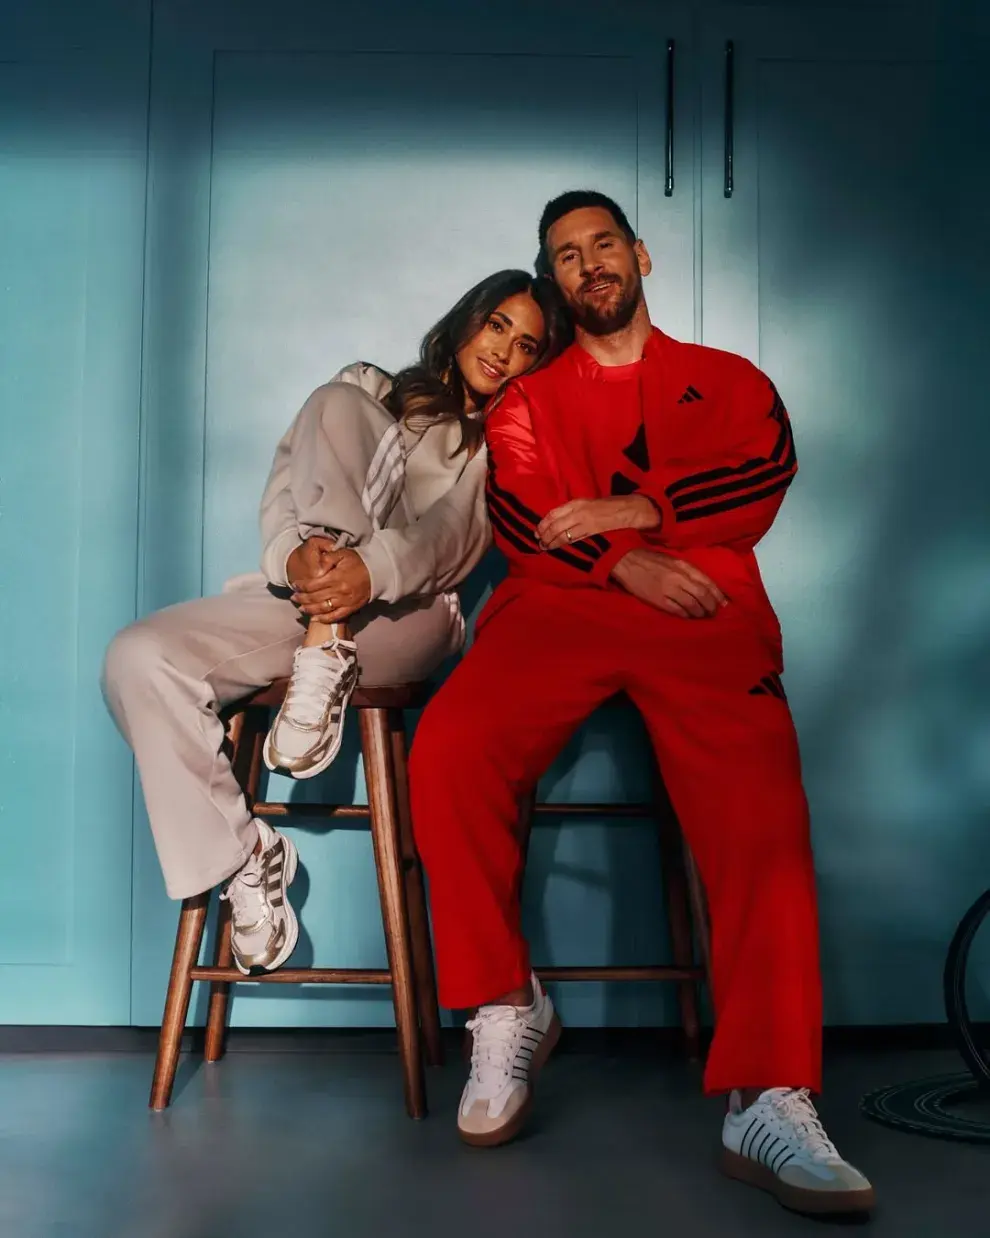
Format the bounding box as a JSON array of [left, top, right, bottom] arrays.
[[519, 771, 712, 1061]]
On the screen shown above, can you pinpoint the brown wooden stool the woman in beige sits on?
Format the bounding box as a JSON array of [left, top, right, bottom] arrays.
[[151, 680, 442, 1118]]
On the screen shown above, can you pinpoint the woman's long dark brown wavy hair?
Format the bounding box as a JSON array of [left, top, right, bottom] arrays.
[[382, 270, 573, 454]]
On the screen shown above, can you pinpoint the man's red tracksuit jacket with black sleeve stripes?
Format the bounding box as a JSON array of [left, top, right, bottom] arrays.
[[479, 328, 797, 661]]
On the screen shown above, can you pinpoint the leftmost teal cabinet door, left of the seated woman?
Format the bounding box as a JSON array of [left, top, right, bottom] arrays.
[[0, 21, 147, 1024]]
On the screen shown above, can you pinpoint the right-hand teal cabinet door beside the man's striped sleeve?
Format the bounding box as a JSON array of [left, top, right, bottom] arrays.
[[700, 9, 988, 1023]]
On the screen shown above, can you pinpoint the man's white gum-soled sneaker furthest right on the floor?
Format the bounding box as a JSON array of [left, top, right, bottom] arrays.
[[721, 1087, 875, 1214]]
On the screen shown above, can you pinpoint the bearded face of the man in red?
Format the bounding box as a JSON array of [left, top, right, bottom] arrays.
[[547, 207, 650, 335]]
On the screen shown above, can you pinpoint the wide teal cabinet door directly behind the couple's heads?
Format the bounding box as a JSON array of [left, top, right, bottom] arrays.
[[135, 2, 694, 1024]]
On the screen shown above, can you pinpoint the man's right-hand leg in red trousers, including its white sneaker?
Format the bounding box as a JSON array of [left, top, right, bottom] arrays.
[[627, 599, 872, 1212]]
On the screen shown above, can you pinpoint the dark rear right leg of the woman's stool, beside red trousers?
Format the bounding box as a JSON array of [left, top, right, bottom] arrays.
[[389, 709, 443, 1066]]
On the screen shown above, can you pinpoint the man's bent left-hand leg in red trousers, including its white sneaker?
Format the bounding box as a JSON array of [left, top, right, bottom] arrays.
[[410, 582, 618, 1144]]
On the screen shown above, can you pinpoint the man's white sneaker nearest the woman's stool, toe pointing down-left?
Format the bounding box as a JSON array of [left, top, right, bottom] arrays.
[[457, 976, 561, 1148]]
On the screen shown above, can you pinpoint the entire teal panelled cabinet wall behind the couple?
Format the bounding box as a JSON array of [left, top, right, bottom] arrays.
[[0, 0, 990, 1025]]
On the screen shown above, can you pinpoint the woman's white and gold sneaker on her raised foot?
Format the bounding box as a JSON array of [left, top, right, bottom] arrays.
[[265, 640, 358, 777]]
